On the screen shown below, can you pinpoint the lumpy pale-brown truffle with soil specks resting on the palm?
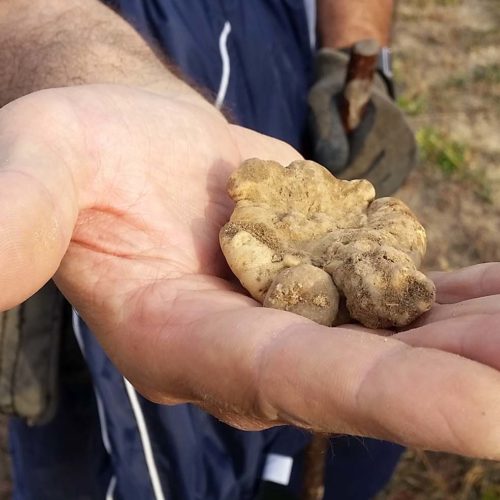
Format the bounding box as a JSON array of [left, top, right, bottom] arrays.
[[220, 158, 435, 329]]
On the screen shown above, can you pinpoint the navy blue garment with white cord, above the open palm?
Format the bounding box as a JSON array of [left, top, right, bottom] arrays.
[[108, 0, 312, 147]]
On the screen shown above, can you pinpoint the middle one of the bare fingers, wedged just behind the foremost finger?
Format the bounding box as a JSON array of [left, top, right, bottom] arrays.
[[394, 312, 500, 370]]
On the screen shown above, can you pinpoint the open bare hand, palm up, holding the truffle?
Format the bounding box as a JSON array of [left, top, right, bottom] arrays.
[[0, 86, 500, 458]]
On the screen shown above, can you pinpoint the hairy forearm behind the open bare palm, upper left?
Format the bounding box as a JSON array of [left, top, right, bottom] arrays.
[[0, 0, 208, 106]]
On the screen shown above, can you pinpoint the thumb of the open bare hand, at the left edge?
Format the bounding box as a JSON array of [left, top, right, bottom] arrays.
[[0, 93, 78, 304]]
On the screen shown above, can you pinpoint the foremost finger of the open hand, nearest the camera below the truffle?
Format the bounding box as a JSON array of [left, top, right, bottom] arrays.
[[254, 318, 500, 458]]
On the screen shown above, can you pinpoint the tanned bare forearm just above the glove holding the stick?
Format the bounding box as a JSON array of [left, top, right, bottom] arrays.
[[317, 0, 394, 48]]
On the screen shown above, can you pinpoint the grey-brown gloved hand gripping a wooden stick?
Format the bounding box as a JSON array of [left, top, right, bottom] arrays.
[[308, 48, 417, 197]]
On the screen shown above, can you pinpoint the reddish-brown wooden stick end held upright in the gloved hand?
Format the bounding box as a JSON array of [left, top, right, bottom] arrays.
[[340, 40, 380, 133]]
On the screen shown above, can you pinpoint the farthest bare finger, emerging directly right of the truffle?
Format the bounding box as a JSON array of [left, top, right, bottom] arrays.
[[429, 262, 500, 304]]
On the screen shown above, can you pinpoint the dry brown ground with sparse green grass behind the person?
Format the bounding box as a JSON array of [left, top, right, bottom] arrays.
[[0, 0, 500, 500]]
